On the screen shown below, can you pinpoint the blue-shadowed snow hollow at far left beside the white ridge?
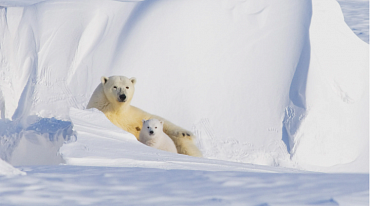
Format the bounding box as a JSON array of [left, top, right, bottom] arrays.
[[0, 115, 76, 166]]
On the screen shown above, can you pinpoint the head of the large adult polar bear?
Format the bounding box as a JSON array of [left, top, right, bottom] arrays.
[[101, 76, 136, 103]]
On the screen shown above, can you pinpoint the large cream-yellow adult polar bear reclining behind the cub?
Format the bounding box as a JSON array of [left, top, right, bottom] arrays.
[[87, 76, 202, 157]]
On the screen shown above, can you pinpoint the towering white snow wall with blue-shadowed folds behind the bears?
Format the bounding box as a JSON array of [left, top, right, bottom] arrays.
[[0, 0, 369, 172]]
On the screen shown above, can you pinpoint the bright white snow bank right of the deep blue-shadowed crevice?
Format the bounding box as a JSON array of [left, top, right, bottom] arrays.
[[291, 1, 369, 171]]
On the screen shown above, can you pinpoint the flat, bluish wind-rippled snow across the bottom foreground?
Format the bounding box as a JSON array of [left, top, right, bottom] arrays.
[[0, 165, 369, 206]]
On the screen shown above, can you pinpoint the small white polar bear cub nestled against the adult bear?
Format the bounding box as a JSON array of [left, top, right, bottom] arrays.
[[139, 119, 177, 153]]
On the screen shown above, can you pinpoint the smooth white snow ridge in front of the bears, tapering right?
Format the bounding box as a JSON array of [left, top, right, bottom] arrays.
[[60, 108, 298, 173]]
